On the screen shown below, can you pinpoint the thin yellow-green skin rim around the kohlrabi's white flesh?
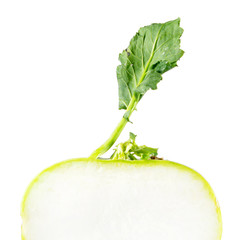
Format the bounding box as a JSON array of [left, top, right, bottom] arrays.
[[21, 158, 222, 240]]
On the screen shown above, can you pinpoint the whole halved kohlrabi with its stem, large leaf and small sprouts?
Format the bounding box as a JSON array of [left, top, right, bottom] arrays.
[[21, 19, 222, 240]]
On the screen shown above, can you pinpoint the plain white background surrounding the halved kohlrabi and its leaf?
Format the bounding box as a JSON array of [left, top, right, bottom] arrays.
[[0, 0, 243, 240]]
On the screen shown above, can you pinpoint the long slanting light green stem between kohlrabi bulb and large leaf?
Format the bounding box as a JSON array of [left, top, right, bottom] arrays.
[[90, 96, 138, 158]]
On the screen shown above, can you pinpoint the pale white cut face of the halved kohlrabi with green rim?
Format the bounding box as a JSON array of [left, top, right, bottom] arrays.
[[21, 159, 222, 240]]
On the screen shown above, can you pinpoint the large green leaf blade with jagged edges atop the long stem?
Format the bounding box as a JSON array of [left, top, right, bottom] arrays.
[[117, 18, 183, 109]]
